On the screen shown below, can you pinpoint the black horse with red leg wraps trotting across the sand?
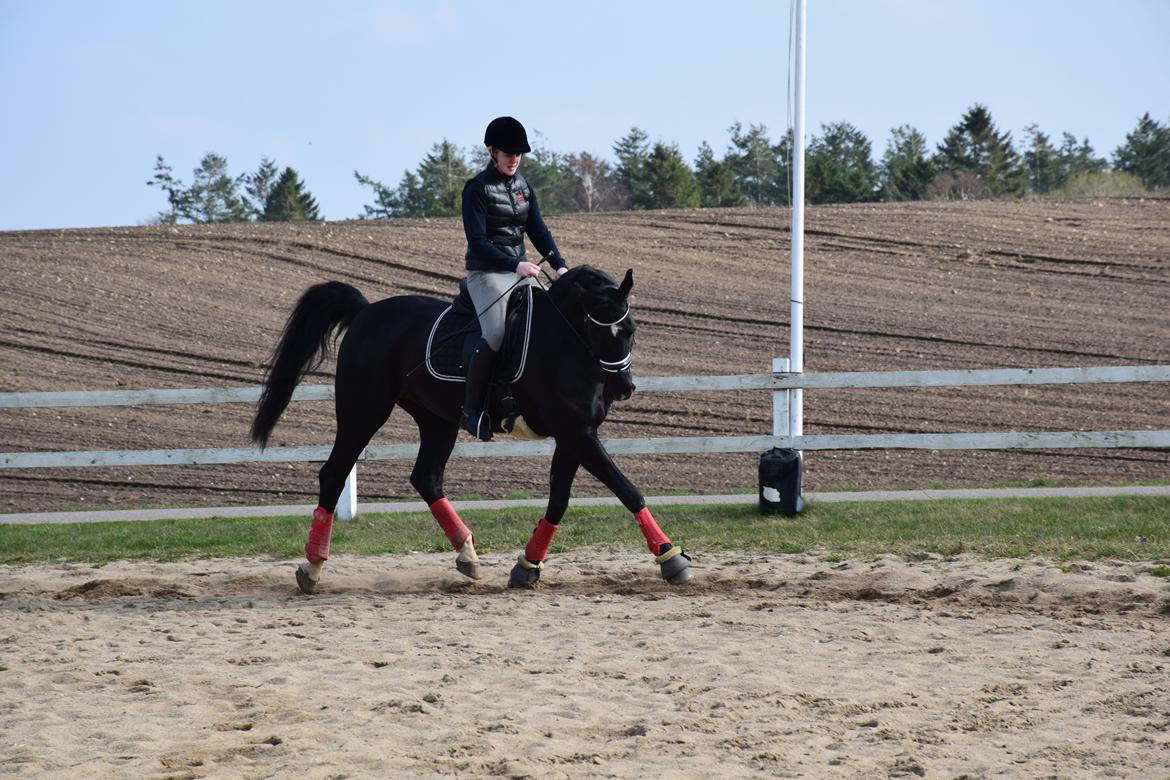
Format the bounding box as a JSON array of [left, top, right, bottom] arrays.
[[252, 265, 690, 593]]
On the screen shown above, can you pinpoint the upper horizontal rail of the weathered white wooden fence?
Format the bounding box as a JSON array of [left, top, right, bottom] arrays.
[[0, 365, 1170, 409]]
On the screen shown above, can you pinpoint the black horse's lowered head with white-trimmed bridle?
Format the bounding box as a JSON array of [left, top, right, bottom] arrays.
[[562, 267, 636, 401]]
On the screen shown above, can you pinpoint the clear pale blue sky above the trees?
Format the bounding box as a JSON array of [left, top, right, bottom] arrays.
[[0, 0, 1170, 230]]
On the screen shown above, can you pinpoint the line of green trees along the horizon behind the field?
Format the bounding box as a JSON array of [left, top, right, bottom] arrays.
[[147, 104, 1170, 222]]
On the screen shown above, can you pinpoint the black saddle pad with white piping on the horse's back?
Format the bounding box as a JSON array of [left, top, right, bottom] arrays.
[[427, 279, 532, 384]]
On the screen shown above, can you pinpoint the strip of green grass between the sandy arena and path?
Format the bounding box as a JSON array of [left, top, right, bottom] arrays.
[[0, 496, 1170, 564]]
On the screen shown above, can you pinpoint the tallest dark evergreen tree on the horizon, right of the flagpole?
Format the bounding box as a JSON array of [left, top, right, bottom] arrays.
[[934, 103, 1026, 196]]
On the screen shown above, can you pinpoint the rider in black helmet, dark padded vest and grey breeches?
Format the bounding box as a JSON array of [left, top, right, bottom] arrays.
[[460, 117, 569, 441]]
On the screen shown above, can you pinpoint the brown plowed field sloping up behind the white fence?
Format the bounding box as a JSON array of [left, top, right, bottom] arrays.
[[0, 199, 1170, 511]]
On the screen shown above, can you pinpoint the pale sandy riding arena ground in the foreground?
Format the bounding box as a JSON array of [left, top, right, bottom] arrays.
[[0, 552, 1170, 780]]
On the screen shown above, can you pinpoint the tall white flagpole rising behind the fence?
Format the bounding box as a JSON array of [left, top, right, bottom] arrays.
[[789, 0, 806, 436]]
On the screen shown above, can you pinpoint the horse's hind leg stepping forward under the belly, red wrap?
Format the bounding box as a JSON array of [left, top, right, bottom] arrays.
[[402, 405, 480, 580]]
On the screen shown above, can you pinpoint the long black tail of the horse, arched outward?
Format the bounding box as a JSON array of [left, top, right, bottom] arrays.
[[252, 282, 370, 448]]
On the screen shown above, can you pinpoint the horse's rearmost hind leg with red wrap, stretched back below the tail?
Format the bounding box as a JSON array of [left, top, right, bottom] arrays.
[[296, 370, 394, 593]]
